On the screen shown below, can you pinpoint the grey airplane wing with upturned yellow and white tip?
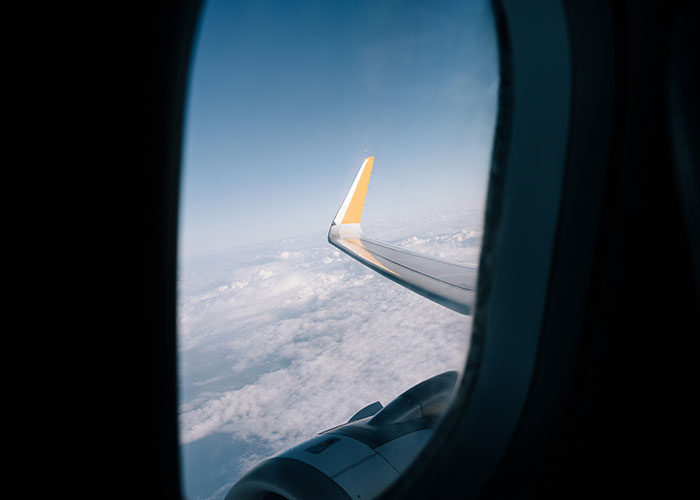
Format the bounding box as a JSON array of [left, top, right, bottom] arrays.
[[328, 156, 477, 314]]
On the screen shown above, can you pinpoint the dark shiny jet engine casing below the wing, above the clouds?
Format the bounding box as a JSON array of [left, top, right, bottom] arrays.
[[226, 371, 457, 500]]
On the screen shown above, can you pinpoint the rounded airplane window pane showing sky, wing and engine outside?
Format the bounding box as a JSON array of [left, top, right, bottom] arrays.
[[178, 0, 499, 499]]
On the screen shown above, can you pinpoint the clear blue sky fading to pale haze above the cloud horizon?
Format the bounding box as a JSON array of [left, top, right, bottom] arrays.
[[180, 0, 498, 257]]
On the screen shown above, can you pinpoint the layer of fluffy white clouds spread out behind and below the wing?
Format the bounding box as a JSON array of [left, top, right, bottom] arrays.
[[179, 210, 481, 488]]
